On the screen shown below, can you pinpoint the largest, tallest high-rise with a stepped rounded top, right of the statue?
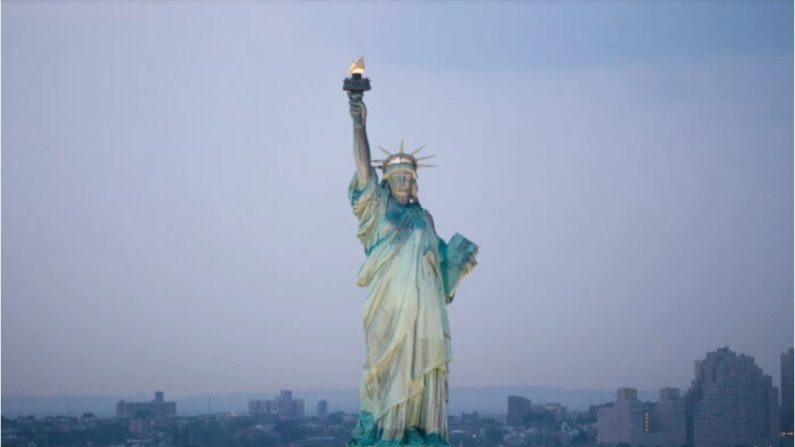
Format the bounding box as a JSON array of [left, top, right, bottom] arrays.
[[687, 347, 781, 447]]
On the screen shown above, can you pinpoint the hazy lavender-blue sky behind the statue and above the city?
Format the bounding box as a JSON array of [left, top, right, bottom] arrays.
[[2, 1, 793, 396]]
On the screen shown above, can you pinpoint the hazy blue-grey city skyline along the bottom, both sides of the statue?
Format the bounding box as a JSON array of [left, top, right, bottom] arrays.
[[3, 348, 793, 447]]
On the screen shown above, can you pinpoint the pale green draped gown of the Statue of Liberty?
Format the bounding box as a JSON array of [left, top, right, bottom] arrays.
[[348, 170, 451, 446]]
